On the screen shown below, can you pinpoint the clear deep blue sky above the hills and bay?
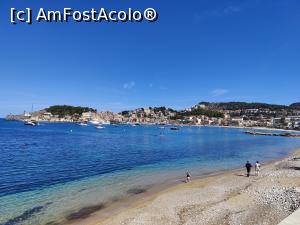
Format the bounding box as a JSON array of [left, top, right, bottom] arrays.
[[0, 0, 300, 116]]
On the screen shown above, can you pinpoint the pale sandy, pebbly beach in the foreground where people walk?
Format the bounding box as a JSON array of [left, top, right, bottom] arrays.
[[70, 150, 300, 225]]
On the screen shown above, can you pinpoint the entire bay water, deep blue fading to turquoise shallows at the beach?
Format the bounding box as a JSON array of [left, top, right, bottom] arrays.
[[0, 120, 300, 225]]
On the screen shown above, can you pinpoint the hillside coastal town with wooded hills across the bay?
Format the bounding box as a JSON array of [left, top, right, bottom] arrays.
[[6, 102, 300, 130]]
